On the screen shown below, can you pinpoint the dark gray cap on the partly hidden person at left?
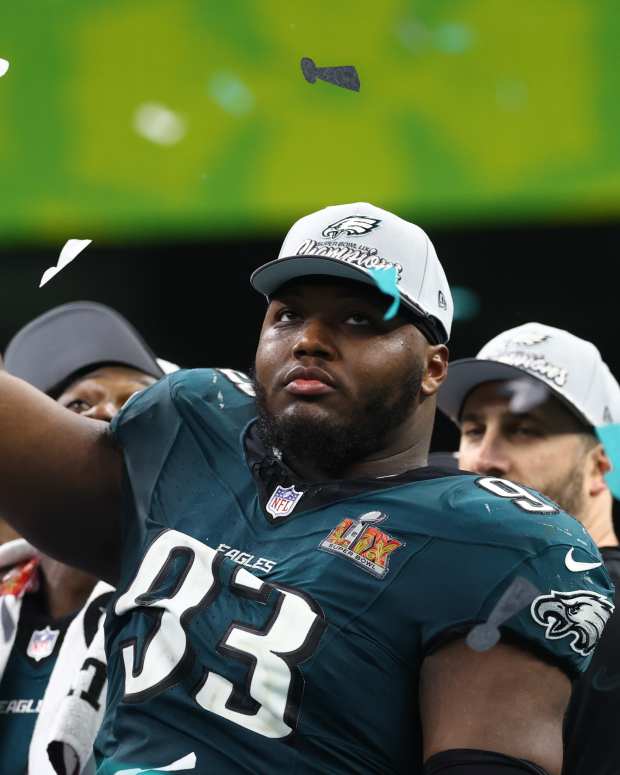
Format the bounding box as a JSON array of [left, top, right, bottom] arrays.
[[4, 301, 164, 394]]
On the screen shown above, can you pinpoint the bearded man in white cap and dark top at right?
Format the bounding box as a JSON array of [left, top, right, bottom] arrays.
[[438, 323, 620, 775]]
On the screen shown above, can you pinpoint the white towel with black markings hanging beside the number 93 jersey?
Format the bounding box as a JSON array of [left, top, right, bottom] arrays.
[[28, 581, 113, 775]]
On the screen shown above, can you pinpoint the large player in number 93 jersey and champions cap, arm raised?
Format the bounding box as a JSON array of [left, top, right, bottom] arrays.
[[0, 202, 613, 775]]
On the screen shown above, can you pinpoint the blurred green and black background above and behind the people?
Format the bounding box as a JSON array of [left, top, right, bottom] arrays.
[[0, 0, 620, 448]]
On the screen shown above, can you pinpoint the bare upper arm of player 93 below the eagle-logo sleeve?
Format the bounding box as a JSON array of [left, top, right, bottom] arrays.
[[420, 640, 571, 775]]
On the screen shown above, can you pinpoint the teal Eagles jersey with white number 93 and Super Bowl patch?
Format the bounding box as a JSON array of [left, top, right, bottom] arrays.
[[97, 369, 613, 775]]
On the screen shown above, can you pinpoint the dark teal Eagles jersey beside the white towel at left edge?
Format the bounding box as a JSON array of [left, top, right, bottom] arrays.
[[0, 594, 70, 775]]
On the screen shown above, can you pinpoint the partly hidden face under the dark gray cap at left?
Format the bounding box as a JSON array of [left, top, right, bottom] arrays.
[[58, 366, 156, 422]]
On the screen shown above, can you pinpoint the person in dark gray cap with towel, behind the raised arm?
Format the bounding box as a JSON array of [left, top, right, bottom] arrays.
[[0, 302, 164, 775]]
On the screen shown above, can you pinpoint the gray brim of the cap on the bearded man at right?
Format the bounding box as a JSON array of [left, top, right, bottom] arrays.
[[437, 358, 592, 426]]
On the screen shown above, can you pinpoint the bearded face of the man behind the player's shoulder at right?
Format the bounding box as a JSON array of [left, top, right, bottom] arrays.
[[459, 382, 586, 516]]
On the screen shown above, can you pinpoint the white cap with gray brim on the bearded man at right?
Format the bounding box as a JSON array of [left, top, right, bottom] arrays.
[[438, 323, 620, 427]]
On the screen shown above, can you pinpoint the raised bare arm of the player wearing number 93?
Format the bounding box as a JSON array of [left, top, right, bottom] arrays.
[[0, 368, 122, 583]]
